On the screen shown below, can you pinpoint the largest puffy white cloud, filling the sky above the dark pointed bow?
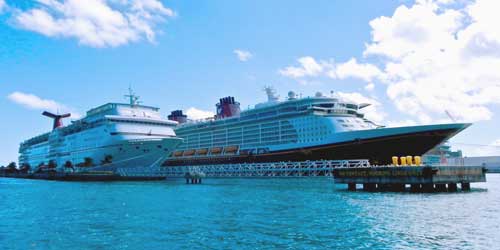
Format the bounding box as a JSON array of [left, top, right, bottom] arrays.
[[280, 0, 500, 123]]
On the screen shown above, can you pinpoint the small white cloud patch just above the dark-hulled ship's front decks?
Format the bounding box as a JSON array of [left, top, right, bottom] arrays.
[[335, 92, 387, 124]]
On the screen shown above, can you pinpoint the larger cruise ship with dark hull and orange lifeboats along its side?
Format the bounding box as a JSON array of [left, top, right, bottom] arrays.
[[163, 87, 471, 166]]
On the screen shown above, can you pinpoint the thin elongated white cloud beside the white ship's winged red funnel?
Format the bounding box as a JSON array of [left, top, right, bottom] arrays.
[[7, 91, 81, 119]]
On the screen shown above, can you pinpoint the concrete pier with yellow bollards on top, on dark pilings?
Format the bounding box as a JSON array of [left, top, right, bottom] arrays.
[[333, 166, 486, 193]]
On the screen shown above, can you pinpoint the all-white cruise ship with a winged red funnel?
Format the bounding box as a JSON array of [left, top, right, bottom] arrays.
[[19, 90, 182, 171]]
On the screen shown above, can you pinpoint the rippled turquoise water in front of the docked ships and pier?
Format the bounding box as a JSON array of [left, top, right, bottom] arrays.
[[0, 174, 500, 249]]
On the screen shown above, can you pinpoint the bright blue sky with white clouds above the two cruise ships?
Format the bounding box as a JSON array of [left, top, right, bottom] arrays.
[[0, 0, 500, 164]]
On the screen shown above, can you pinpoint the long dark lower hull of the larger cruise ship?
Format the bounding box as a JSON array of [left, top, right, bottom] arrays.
[[164, 124, 468, 166]]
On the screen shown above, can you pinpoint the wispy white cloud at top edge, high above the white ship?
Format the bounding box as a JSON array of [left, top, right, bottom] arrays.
[[11, 0, 175, 47]]
